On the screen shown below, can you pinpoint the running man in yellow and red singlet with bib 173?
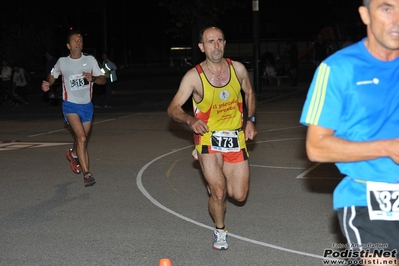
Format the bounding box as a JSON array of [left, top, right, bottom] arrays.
[[168, 27, 257, 250]]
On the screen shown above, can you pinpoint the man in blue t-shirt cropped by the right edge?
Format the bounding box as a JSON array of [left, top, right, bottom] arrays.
[[300, 0, 399, 265]]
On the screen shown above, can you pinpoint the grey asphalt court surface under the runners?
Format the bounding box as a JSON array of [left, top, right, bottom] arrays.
[[0, 78, 345, 266]]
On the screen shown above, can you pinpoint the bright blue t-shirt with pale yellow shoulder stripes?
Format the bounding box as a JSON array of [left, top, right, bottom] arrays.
[[300, 39, 399, 209]]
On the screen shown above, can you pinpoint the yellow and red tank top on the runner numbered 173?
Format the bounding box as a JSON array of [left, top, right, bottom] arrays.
[[192, 58, 246, 153]]
